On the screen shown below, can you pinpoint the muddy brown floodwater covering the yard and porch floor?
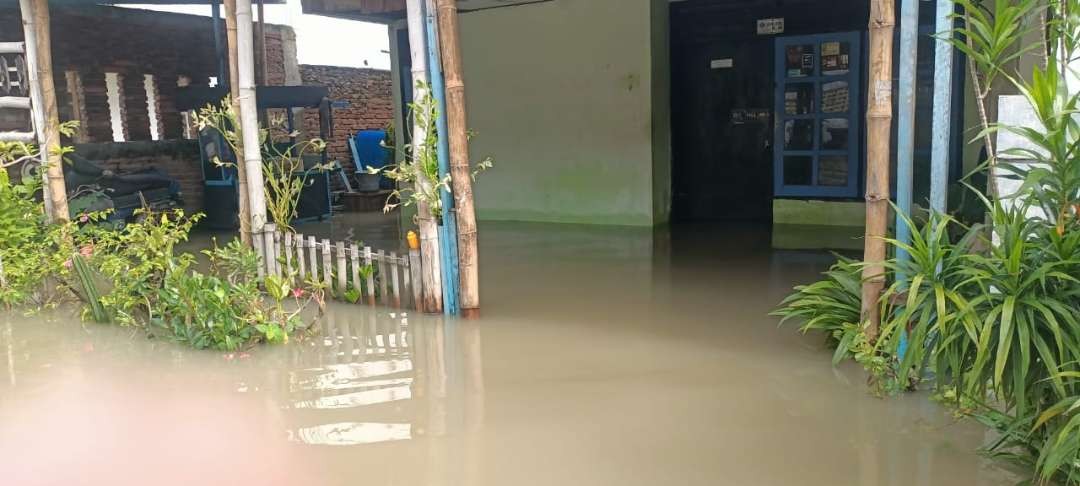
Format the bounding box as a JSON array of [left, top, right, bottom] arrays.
[[0, 219, 1021, 486]]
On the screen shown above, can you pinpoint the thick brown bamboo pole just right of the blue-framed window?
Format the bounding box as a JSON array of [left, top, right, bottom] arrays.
[[862, 0, 895, 339]]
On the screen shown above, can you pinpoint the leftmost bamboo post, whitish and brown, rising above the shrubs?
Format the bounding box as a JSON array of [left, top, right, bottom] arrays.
[[18, 0, 69, 221]]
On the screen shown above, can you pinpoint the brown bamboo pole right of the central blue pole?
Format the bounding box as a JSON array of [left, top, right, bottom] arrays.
[[436, 0, 480, 318]]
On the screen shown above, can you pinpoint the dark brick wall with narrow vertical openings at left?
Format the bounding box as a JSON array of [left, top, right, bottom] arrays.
[[0, 5, 295, 211]]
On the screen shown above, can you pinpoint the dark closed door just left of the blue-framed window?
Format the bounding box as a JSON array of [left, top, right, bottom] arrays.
[[672, 38, 773, 221]]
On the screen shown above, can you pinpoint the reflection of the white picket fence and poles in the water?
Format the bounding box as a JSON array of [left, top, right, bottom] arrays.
[[285, 306, 484, 446]]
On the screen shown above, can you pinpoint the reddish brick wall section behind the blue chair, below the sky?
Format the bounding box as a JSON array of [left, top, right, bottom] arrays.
[[300, 65, 394, 177]]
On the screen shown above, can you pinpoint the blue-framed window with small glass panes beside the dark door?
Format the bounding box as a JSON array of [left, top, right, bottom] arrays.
[[773, 32, 862, 198]]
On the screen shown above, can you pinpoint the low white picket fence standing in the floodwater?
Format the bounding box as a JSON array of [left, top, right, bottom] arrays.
[[256, 224, 421, 310]]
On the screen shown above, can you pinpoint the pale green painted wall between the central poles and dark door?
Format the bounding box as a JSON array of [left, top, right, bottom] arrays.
[[453, 0, 670, 226]]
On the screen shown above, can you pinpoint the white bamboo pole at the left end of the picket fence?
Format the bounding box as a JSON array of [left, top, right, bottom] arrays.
[[235, 0, 267, 254]]
